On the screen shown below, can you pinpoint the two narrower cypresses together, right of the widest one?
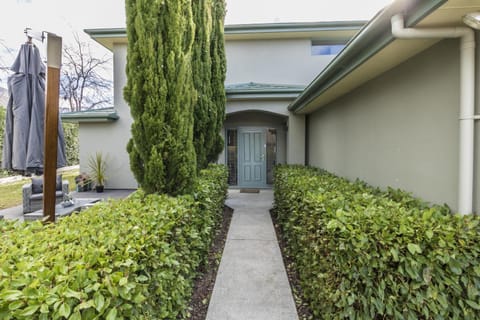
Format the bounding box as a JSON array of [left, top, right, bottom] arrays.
[[192, 0, 226, 168]]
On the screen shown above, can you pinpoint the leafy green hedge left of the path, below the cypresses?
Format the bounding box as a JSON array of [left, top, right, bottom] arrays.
[[0, 166, 227, 319]]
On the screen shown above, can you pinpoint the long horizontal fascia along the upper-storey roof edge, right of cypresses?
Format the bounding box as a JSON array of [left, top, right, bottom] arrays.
[[225, 21, 367, 35]]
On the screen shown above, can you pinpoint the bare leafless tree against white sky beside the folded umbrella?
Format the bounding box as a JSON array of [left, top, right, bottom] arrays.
[[60, 33, 112, 112]]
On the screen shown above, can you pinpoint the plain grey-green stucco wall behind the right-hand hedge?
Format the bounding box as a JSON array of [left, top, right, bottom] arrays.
[[308, 40, 472, 211]]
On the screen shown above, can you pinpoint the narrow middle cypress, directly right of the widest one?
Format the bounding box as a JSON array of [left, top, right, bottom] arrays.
[[192, 0, 216, 169]]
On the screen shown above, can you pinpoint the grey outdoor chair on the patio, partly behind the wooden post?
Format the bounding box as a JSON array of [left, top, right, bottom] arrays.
[[22, 175, 69, 213]]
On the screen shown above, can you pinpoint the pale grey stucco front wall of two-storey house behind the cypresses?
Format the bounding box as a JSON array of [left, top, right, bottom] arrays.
[[79, 39, 326, 188]]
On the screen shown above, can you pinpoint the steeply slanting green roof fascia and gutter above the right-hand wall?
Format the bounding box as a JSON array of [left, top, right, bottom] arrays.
[[288, 0, 448, 112]]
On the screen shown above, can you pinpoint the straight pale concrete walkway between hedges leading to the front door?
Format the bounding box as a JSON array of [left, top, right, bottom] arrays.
[[207, 190, 298, 320]]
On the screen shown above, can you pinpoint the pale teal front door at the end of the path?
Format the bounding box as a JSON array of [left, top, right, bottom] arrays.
[[238, 128, 267, 188]]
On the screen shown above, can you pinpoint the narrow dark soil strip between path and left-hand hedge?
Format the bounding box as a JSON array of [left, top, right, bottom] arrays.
[[186, 206, 233, 320]]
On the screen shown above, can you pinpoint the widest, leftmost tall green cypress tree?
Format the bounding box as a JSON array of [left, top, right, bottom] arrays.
[[124, 0, 196, 195]]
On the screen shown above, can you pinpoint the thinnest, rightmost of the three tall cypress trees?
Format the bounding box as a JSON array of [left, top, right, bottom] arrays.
[[207, 0, 227, 162]]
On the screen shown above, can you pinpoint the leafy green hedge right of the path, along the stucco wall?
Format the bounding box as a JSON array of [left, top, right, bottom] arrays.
[[274, 166, 480, 319]]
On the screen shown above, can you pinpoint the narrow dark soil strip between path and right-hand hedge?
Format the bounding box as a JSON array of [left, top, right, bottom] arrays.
[[270, 210, 314, 320]]
